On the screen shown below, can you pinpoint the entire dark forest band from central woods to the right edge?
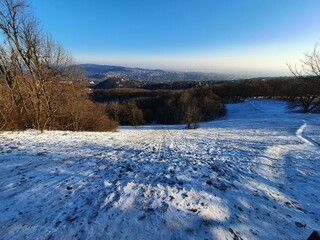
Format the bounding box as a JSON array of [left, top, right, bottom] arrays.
[[90, 77, 320, 128]]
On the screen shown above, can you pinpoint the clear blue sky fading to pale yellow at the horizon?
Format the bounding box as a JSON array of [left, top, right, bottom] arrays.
[[29, 0, 320, 75]]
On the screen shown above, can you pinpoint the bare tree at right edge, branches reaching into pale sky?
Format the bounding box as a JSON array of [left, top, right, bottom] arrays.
[[288, 42, 320, 113]]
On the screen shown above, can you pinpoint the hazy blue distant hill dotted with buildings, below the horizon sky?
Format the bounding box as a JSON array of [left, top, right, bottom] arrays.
[[79, 64, 239, 82]]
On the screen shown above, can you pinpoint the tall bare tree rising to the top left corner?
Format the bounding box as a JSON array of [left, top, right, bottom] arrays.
[[0, 0, 78, 131]]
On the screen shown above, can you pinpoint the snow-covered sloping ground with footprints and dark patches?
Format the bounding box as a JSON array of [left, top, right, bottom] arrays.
[[0, 100, 320, 239]]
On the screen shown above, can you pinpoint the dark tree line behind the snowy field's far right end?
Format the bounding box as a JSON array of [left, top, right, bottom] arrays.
[[214, 75, 320, 113]]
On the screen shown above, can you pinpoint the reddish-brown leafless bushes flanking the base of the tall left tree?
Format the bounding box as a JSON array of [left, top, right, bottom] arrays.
[[0, 81, 118, 131]]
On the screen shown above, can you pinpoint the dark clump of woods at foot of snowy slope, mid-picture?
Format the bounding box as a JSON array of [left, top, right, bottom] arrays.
[[104, 88, 226, 129]]
